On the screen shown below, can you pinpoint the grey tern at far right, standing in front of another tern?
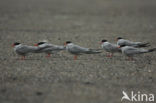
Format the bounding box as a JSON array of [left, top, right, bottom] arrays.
[[119, 45, 156, 60]]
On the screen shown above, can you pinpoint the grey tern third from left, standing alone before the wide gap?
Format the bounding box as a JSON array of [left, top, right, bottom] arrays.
[[65, 41, 101, 60]]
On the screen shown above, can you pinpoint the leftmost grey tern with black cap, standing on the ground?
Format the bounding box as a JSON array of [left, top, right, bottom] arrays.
[[12, 42, 39, 60]]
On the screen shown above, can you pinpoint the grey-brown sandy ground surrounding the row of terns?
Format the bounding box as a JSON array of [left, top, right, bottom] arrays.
[[0, 0, 156, 103]]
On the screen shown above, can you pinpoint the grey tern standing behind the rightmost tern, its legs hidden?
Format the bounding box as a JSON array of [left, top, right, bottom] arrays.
[[117, 37, 150, 47]]
